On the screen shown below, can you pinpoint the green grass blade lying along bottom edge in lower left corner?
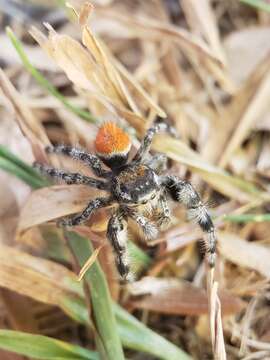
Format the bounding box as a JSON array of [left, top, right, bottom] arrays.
[[0, 330, 100, 360]]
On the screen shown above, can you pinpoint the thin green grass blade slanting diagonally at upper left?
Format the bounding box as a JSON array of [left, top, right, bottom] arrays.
[[6, 27, 98, 123]]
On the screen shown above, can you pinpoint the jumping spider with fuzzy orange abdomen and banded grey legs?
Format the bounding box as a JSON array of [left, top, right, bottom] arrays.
[[35, 122, 216, 279]]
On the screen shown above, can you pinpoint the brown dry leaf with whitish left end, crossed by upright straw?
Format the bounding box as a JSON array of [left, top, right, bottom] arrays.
[[129, 277, 244, 315]]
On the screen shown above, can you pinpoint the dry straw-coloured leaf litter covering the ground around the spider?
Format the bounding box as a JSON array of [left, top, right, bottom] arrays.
[[0, 0, 270, 359]]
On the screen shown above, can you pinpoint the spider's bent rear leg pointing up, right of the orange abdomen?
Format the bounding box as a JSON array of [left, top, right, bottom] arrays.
[[133, 122, 175, 162]]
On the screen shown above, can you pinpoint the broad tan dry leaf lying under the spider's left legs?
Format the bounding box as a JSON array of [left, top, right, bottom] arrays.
[[18, 185, 103, 236]]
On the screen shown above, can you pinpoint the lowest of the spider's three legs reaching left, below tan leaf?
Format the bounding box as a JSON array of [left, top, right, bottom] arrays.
[[58, 197, 112, 226]]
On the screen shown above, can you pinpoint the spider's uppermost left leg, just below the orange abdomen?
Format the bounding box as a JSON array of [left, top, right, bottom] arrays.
[[46, 145, 111, 177]]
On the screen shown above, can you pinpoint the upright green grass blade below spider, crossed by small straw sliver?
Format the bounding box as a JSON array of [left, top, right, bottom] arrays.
[[65, 231, 125, 360]]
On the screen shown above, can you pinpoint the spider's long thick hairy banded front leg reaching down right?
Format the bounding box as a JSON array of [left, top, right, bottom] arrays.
[[163, 176, 216, 267]]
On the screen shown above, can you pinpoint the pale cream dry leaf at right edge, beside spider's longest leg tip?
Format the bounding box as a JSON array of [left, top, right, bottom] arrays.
[[218, 231, 270, 278]]
